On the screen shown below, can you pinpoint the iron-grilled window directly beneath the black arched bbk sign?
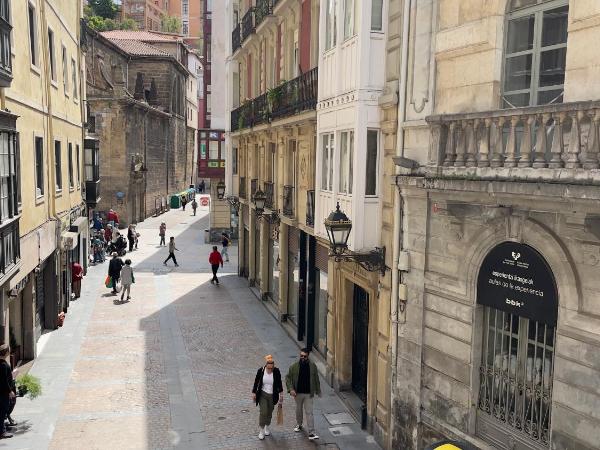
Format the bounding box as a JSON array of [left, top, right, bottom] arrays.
[[478, 307, 555, 446]]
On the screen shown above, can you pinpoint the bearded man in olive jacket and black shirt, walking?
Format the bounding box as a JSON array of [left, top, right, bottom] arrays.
[[285, 348, 321, 441]]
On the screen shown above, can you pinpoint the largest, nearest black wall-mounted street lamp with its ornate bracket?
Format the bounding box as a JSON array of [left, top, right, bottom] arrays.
[[325, 203, 387, 276]]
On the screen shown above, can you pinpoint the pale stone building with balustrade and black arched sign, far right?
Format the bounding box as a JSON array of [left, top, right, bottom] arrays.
[[380, 0, 600, 449]]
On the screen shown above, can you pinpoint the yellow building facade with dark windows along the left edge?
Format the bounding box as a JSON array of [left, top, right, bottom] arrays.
[[0, 0, 88, 363]]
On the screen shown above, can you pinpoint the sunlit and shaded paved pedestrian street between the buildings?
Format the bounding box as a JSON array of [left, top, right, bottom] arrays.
[[8, 202, 378, 450]]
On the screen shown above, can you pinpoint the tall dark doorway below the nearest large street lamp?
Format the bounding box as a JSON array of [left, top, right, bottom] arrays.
[[352, 285, 369, 403]]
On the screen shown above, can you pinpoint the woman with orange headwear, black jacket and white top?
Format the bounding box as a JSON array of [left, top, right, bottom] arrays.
[[252, 355, 283, 440]]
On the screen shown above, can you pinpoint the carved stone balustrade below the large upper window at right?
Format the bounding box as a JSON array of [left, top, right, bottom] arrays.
[[427, 102, 600, 181]]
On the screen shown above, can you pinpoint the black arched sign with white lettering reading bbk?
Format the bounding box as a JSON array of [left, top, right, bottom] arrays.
[[477, 242, 558, 326]]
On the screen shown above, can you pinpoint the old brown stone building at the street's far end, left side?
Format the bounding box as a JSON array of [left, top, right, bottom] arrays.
[[85, 27, 194, 224]]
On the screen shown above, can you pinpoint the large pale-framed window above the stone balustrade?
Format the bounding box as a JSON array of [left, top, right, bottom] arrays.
[[502, 0, 569, 108]]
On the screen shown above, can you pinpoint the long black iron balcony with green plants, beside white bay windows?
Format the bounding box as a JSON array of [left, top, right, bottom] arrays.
[[231, 67, 318, 131]]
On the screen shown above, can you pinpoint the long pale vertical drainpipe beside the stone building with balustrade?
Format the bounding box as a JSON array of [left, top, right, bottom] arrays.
[[389, 0, 411, 448]]
